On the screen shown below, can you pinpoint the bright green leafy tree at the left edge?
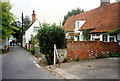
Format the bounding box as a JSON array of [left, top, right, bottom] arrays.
[[0, 1, 19, 40]]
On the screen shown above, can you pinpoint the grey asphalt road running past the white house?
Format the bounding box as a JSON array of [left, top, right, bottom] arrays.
[[2, 46, 55, 79]]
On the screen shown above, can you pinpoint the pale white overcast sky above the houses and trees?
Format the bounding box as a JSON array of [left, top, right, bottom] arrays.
[[10, 0, 115, 24]]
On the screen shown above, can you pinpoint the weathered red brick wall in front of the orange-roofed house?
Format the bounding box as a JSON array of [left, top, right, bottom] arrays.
[[67, 40, 118, 60]]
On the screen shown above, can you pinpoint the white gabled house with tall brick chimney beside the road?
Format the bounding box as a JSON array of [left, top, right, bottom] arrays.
[[23, 10, 40, 47]]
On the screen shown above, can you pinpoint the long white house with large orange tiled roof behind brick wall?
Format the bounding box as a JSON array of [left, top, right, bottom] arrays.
[[63, 0, 120, 42]]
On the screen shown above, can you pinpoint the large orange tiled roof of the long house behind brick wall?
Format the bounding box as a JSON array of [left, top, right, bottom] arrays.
[[63, 2, 120, 33]]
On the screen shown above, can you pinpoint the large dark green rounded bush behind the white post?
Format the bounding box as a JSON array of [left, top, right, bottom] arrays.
[[37, 23, 66, 65]]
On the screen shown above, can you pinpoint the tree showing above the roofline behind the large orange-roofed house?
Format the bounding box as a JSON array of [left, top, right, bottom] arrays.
[[62, 8, 84, 25]]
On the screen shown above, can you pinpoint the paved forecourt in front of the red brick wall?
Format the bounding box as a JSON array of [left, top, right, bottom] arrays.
[[46, 58, 119, 81]]
